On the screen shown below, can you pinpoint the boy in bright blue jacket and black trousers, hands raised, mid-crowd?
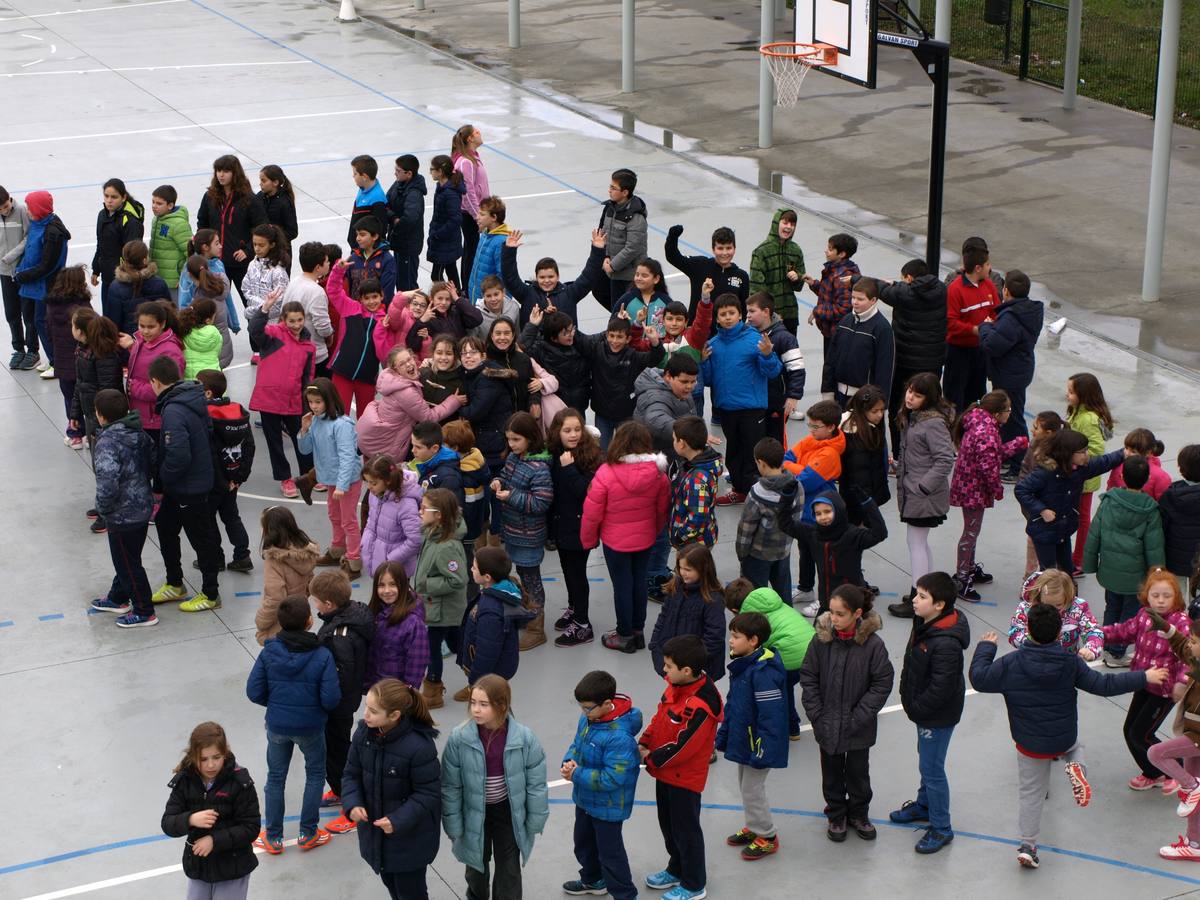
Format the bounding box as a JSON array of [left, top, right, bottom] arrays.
[[701, 294, 782, 506]]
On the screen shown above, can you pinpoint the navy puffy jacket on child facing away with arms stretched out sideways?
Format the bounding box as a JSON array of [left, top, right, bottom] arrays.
[[971, 641, 1146, 756]]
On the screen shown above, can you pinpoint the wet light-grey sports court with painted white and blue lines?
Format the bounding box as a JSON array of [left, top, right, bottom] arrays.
[[0, 0, 1200, 900]]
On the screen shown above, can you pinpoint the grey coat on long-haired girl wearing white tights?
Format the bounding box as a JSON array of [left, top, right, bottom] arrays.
[[896, 409, 954, 521]]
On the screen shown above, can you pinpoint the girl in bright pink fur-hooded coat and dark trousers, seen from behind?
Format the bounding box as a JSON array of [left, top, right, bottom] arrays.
[[580, 422, 671, 653]]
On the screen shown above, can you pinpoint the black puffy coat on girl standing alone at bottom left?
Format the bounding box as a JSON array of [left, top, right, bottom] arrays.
[[162, 756, 260, 884]]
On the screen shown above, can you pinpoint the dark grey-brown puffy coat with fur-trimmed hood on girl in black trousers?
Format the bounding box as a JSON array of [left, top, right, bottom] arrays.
[[800, 611, 895, 754]]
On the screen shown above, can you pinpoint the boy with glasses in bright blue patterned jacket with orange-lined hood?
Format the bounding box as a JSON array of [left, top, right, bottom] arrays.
[[562, 671, 642, 900]]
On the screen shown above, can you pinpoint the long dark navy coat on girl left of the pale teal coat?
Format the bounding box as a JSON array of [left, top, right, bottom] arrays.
[[342, 716, 442, 872]]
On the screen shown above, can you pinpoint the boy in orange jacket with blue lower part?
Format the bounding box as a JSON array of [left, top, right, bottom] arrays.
[[784, 400, 846, 617]]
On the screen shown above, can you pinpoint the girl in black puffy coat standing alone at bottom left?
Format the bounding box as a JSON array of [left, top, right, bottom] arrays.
[[155, 724, 259, 900]]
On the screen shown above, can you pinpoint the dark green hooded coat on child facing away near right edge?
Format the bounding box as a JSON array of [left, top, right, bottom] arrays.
[[1084, 487, 1166, 595]]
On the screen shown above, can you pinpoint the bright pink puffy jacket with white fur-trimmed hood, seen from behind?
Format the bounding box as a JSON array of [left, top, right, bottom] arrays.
[[580, 454, 671, 553]]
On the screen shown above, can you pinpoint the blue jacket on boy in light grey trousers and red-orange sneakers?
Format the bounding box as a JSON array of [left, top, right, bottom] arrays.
[[716, 647, 790, 769]]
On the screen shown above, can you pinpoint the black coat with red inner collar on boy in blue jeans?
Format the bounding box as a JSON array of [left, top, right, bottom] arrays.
[[900, 608, 971, 728]]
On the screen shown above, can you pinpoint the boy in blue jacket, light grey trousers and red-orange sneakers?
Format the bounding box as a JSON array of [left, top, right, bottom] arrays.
[[716, 612, 787, 862]]
